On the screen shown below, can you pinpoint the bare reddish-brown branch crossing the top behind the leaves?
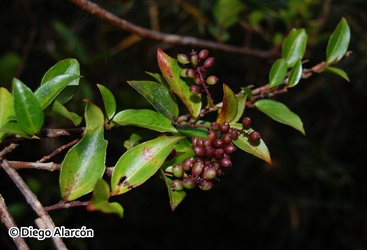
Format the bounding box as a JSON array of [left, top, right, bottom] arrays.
[[70, 0, 279, 58]]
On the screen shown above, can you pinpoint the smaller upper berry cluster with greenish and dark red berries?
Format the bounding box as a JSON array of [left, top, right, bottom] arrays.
[[177, 49, 219, 96]]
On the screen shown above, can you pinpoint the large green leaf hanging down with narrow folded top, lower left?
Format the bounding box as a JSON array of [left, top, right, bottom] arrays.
[[59, 102, 107, 201]]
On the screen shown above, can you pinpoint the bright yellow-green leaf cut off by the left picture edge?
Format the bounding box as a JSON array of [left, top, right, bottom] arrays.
[[0, 87, 15, 142]]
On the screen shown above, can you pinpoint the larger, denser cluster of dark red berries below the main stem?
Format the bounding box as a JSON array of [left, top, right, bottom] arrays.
[[171, 122, 238, 191]]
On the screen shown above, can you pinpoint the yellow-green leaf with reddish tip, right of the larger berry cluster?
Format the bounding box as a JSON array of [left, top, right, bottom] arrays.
[[231, 123, 272, 165]]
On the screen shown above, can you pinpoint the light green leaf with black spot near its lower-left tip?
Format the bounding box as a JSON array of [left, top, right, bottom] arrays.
[[111, 136, 183, 195]]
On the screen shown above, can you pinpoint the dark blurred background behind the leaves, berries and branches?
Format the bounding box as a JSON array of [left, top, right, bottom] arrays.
[[0, 0, 367, 250]]
